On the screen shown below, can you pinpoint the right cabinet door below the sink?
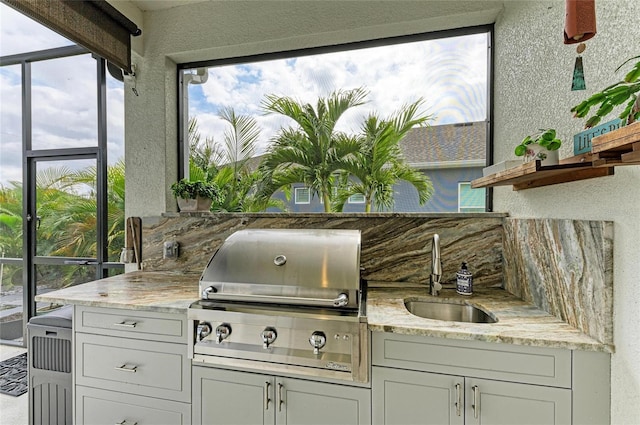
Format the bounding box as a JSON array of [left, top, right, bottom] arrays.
[[466, 378, 571, 425]]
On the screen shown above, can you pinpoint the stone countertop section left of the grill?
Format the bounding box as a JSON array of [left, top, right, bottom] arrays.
[[36, 271, 200, 314]]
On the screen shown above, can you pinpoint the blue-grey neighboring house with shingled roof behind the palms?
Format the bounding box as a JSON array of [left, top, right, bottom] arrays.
[[274, 121, 487, 212]]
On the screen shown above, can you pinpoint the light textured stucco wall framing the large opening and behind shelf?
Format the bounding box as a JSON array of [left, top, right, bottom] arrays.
[[125, 0, 640, 424]]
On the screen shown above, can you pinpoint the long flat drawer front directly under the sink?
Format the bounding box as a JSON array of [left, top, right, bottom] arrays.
[[372, 332, 571, 388]]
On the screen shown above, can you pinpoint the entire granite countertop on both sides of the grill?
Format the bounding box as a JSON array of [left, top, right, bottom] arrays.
[[36, 271, 613, 352]]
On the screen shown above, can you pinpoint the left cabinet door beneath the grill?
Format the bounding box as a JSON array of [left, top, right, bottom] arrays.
[[192, 367, 275, 425]]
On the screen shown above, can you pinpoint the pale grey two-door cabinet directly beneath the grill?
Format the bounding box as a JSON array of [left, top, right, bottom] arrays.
[[193, 366, 371, 425]]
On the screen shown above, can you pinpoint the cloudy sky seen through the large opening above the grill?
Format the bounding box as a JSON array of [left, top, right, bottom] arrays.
[[189, 34, 487, 153]]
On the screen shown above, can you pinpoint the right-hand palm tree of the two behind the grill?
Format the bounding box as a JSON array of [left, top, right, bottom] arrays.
[[334, 100, 433, 212]]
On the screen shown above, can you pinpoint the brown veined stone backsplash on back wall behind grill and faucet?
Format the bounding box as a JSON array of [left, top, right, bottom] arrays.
[[142, 214, 503, 286]]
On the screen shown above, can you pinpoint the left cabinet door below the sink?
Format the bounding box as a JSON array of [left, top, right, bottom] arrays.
[[371, 367, 464, 425]]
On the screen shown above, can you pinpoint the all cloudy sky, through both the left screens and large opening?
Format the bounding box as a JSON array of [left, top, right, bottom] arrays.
[[0, 4, 487, 185]]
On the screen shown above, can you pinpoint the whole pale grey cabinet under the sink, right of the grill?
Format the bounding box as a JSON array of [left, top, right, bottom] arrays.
[[372, 332, 610, 425]]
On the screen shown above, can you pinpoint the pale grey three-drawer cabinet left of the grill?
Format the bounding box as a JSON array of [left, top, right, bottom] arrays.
[[74, 306, 191, 425]]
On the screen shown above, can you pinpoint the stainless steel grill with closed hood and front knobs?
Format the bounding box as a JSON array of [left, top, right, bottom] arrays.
[[189, 229, 368, 382]]
